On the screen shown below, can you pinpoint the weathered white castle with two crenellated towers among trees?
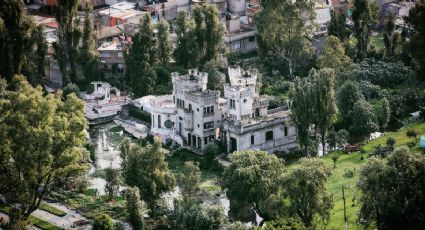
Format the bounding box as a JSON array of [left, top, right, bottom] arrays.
[[133, 67, 297, 153]]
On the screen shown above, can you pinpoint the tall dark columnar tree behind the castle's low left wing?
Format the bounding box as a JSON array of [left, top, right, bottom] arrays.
[[125, 14, 157, 97]]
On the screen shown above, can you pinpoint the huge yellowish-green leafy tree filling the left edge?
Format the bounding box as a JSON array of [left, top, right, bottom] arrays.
[[0, 76, 88, 219]]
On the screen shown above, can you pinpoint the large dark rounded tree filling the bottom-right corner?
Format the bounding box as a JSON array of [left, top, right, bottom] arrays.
[[357, 147, 425, 229]]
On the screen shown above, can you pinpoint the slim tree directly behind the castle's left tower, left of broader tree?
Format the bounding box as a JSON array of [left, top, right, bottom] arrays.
[[173, 11, 196, 68]]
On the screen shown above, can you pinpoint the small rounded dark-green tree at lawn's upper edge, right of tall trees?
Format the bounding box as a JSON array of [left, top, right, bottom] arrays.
[[350, 100, 378, 138]]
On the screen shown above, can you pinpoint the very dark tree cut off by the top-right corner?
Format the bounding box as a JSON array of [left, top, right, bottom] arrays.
[[405, 2, 425, 80]]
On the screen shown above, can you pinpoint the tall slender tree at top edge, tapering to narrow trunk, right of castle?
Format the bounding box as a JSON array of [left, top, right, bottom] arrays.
[[352, 0, 377, 59]]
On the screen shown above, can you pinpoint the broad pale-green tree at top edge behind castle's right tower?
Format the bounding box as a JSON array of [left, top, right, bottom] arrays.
[[255, 0, 314, 79]]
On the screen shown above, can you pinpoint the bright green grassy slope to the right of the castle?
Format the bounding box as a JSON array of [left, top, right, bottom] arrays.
[[288, 123, 425, 230]]
